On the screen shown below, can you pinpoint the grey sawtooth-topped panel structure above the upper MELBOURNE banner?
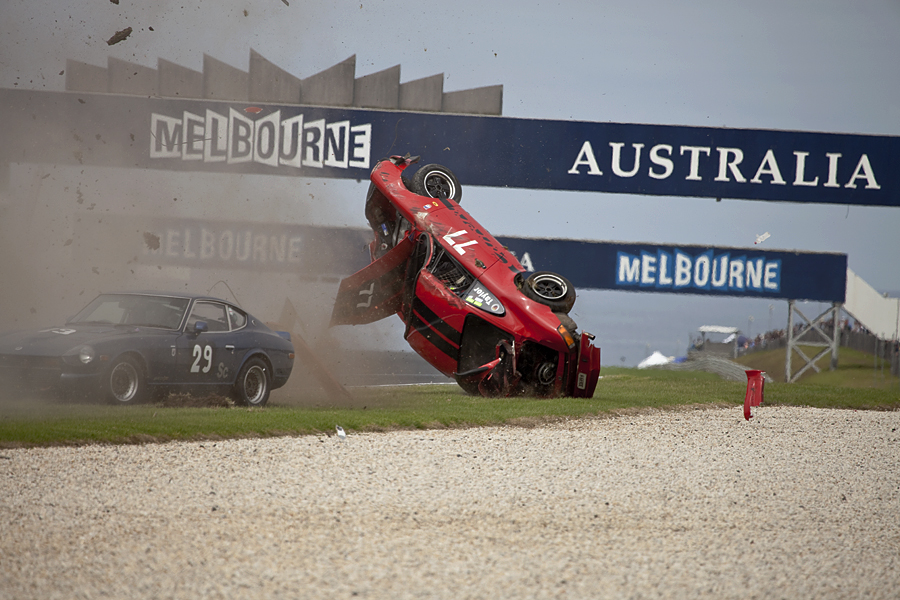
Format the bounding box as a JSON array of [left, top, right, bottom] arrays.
[[60, 49, 503, 115]]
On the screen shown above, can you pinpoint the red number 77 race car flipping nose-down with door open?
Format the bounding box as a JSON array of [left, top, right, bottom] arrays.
[[331, 155, 600, 398]]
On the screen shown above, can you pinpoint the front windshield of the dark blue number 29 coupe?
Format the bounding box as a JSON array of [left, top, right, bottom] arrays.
[[69, 294, 190, 329]]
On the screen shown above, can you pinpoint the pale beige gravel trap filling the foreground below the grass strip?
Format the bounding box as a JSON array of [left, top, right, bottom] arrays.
[[0, 407, 900, 600]]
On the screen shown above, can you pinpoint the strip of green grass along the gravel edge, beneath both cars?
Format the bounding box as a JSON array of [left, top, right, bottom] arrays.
[[0, 366, 900, 448]]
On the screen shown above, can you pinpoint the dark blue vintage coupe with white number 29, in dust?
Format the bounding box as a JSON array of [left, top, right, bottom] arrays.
[[0, 292, 294, 406]]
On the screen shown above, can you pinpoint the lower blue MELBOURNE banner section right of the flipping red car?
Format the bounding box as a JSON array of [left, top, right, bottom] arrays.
[[497, 237, 847, 302]]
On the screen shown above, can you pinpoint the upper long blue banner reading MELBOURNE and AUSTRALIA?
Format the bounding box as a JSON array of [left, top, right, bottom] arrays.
[[0, 89, 900, 206]]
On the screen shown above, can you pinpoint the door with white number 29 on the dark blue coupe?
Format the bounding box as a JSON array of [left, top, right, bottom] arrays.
[[176, 300, 233, 385]]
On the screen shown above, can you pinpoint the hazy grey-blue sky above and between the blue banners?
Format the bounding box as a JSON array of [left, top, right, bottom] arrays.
[[0, 0, 900, 364]]
